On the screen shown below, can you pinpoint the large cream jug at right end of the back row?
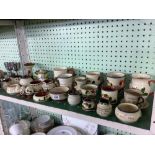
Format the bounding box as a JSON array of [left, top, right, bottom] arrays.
[[129, 73, 155, 98]]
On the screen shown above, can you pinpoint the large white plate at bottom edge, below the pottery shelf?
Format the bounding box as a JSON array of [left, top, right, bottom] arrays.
[[47, 126, 78, 135]]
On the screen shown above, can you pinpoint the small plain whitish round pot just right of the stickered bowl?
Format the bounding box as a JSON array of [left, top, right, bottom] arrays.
[[68, 93, 81, 106]]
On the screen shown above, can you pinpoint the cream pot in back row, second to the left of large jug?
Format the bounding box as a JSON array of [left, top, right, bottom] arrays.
[[86, 71, 101, 85]]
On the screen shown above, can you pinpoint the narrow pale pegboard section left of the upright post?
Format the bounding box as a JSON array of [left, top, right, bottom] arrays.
[[0, 26, 20, 71]]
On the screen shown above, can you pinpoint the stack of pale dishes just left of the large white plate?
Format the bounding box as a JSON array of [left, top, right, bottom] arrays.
[[31, 115, 54, 133]]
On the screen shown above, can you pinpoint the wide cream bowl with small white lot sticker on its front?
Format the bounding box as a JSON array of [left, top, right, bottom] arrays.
[[50, 87, 69, 100]]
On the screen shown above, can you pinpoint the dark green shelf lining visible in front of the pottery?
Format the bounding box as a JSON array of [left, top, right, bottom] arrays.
[[0, 90, 154, 130]]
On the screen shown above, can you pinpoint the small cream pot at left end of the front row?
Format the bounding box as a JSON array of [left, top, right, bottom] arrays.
[[6, 84, 20, 95]]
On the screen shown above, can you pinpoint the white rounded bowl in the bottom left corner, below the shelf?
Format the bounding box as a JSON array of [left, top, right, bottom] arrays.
[[9, 123, 30, 135]]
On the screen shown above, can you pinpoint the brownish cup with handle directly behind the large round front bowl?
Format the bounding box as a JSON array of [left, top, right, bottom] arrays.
[[124, 89, 144, 104]]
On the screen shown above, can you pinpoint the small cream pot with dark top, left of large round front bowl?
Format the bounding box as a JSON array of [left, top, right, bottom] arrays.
[[96, 99, 112, 117]]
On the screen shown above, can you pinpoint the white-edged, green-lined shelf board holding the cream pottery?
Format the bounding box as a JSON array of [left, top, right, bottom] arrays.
[[0, 90, 153, 134]]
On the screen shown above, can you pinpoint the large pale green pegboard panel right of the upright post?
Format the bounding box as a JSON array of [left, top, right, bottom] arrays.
[[25, 20, 155, 75]]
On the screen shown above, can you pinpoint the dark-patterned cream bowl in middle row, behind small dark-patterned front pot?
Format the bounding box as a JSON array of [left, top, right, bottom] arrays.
[[81, 84, 98, 96]]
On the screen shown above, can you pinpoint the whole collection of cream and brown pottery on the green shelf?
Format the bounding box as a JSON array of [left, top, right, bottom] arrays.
[[0, 63, 155, 125]]
